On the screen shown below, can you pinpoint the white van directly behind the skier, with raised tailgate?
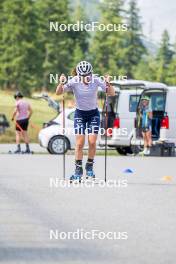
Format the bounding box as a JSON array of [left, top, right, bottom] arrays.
[[100, 80, 147, 155]]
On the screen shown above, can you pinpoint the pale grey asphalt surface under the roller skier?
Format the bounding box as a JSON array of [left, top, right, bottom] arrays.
[[0, 155, 176, 264]]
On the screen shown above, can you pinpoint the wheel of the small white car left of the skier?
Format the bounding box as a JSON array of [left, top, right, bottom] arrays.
[[47, 135, 70, 155]]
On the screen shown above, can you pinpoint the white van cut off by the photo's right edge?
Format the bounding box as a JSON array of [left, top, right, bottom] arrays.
[[132, 86, 176, 146]]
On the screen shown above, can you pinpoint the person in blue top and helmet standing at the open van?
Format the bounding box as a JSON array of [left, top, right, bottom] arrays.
[[140, 96, 153, 155]]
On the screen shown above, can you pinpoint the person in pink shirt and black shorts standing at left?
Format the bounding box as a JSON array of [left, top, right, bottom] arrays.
[[12, 91, 32, 154]]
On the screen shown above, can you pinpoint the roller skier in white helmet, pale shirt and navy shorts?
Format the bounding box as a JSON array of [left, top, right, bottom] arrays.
[[56, 61, 115, 181]]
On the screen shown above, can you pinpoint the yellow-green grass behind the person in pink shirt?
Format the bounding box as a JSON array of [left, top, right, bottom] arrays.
[[0, 91, 56, 143]]
